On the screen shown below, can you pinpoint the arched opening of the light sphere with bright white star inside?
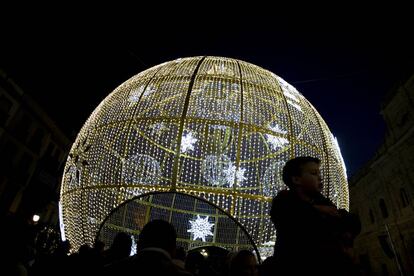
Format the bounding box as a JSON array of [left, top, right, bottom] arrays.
[[97, 192, 262, 255]]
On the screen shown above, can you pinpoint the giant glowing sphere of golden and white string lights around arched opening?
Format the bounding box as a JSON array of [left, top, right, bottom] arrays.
[[60, 57, 349, 255]]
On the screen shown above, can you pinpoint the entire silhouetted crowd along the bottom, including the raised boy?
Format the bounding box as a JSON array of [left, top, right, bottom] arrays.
[[1, 157, 363, 276]]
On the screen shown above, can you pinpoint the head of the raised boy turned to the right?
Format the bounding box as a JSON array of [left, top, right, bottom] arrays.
[[282, 156, 322, 193]]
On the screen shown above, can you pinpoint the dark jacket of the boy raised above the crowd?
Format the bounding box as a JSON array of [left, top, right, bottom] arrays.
[[270, 191, 358, 275]]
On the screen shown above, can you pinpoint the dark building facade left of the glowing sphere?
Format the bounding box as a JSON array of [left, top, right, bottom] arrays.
[[0, 70, 70, 224]]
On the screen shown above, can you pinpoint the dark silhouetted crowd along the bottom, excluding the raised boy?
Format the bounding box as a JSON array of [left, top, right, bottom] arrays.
[[1, 219, 259, 276]]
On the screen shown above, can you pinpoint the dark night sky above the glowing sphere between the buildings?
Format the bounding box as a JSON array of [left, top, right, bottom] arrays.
[[0, 7, 414, 176]]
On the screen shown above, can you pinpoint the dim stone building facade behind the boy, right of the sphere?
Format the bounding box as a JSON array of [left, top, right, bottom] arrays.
[[350, 75, 414, 275]]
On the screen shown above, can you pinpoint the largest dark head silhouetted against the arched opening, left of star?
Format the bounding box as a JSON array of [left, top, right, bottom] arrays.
[[137, 219, 177, 256]]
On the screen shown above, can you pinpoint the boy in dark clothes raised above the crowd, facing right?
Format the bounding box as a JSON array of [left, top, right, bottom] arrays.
[[270, 156, 360, 275]]
